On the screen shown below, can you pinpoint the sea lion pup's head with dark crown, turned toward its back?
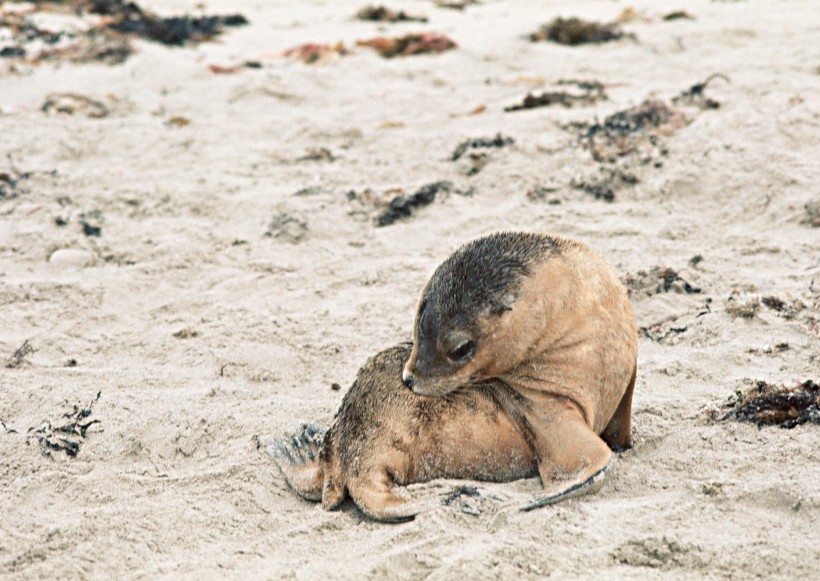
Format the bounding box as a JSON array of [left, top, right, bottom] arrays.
[[402, 232, 555, 396]]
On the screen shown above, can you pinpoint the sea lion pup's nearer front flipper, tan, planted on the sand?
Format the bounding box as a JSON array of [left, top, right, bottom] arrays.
[[521, 394, 613, 510]]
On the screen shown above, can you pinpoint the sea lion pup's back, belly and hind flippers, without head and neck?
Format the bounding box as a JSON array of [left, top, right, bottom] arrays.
[[269, 343, 538, 521]]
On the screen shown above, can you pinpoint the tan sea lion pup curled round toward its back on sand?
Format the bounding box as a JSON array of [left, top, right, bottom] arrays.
[[272, 233, 637, 520]]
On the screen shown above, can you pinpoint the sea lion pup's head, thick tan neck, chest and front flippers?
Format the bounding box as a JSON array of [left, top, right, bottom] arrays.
[[403, 232, 638, 509]]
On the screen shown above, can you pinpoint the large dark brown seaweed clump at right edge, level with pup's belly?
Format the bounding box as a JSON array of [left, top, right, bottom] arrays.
[[710, 379, 820, 429]]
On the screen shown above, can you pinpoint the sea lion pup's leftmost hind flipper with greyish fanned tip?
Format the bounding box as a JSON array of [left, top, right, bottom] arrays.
[[268, 424, 325, 502]]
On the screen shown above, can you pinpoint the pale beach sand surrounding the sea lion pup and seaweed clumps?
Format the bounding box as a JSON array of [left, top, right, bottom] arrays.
[[0, 0, 820, 579]]
